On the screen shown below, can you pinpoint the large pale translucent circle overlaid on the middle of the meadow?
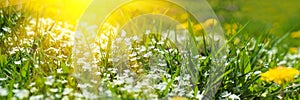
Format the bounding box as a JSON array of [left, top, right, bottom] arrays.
[[73, 0, 226, 99]]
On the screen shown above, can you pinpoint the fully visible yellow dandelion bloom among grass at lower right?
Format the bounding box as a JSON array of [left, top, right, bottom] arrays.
[[260, 66, 299, 85]]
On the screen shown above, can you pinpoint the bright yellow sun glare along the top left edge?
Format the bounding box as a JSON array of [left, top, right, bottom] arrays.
[[21, 0, 92, 24]]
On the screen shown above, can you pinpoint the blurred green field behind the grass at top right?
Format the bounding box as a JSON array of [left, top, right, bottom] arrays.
[[208, 0, 300, 46]]
